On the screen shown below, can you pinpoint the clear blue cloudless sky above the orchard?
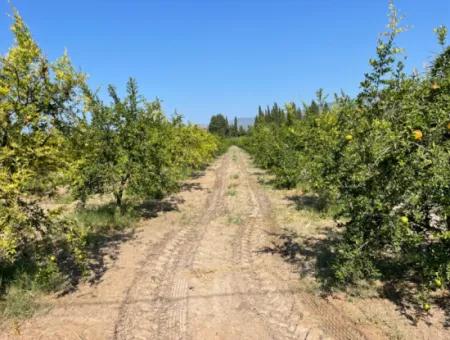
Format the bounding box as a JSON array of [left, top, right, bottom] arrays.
[[0, 0, 450, 123]]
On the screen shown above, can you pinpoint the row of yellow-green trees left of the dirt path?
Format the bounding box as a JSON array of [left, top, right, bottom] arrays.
[[0, 12, 218, 289]]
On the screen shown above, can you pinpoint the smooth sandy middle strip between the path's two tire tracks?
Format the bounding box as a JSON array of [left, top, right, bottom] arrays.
[[184, 148, 274, 340]]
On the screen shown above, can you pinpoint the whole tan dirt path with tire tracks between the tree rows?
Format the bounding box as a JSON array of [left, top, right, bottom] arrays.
[[3, 147, 382, 339]]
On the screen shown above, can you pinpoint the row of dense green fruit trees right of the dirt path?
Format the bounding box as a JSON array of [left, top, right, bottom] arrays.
[[245, 6, 450, 302]]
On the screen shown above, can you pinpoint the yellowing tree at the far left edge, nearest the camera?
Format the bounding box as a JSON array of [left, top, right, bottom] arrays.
[[0, 12, 84, 289]]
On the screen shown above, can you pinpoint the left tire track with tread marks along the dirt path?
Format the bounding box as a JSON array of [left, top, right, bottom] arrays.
[[114, 155, 229, 339]]
